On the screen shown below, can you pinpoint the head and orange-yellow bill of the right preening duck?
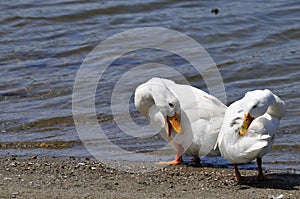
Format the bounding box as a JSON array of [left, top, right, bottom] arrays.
[[239, 89, 275, 136]]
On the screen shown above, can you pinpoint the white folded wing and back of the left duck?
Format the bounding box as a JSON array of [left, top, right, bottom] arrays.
[[170, 84, 227, 156]]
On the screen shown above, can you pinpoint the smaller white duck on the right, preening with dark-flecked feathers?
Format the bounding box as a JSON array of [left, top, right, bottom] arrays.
[[217, 90, 286, 180]]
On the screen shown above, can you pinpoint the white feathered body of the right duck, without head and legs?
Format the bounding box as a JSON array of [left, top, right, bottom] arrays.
[[217, 100, 276, 163]]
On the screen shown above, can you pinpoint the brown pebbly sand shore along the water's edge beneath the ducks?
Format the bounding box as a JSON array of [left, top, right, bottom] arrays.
[[0, 156, 300, 199]]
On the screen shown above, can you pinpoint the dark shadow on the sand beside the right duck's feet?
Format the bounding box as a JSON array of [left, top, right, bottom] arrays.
[[237, 173, 300, 190]]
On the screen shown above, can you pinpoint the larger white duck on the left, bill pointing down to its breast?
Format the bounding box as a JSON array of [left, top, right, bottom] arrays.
[[134, 78, 226, 164]]
